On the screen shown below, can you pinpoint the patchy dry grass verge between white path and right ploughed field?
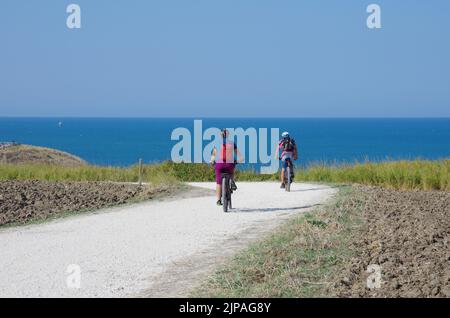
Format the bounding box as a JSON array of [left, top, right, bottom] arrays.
[[193, 187, 363, 298]]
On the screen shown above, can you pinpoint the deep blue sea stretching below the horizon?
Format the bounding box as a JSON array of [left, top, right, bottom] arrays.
[[0, 118, 450, 166]]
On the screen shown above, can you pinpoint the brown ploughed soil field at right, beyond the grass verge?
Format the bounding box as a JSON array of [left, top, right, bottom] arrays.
[[330, 187, 450, 297]]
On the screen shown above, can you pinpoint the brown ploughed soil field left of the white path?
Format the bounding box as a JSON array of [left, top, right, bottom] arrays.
[[0, 181, 174, 226]]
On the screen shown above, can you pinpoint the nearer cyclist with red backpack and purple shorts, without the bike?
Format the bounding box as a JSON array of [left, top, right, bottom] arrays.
[[211, 129, 242, 205]]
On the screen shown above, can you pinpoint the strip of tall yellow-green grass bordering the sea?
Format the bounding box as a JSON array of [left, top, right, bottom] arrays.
[[0, 159, 450, 190]]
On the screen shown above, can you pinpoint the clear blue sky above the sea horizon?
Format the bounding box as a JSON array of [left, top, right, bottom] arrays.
[[0, 0, 450, 117]]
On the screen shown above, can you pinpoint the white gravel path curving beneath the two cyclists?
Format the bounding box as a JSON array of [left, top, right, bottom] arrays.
[[0, 182, 336, 297]]
